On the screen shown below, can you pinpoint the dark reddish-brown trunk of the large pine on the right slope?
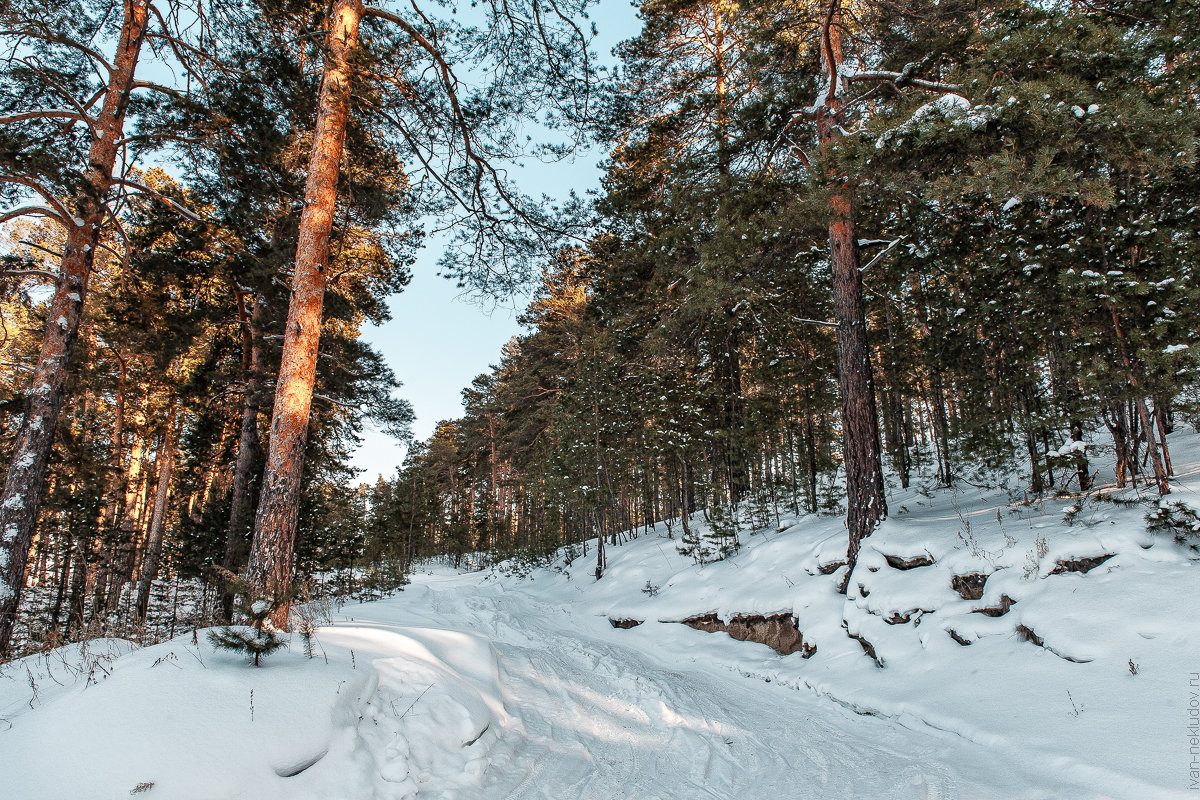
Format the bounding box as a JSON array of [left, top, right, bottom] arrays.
[[816, 0, 888, 591]]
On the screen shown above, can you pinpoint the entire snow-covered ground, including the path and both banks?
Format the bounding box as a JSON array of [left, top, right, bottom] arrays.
[[0, 433, 1200, 800]]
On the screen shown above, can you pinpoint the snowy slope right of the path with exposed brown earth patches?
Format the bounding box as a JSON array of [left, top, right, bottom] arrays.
[[504, 432, 1200, 800]]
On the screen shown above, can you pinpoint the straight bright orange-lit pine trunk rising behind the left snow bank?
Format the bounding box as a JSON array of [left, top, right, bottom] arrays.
[[250, 0, 362, 627]]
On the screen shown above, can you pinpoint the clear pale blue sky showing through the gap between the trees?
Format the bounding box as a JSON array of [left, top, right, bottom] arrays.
[[353, 0, 640, 482]]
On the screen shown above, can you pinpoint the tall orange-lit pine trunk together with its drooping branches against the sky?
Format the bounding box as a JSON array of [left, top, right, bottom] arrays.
[[248, 0, 587, 624]]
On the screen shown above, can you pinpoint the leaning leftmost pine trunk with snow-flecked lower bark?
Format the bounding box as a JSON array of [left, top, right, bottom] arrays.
[[0, 0, 148, 655]]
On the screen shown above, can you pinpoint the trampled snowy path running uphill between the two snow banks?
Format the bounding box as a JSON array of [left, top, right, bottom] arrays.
[[331, 578, 1050, 800]]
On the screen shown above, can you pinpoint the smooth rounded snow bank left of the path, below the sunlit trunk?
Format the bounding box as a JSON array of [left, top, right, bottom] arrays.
[[0, 625, 504, 800]]
